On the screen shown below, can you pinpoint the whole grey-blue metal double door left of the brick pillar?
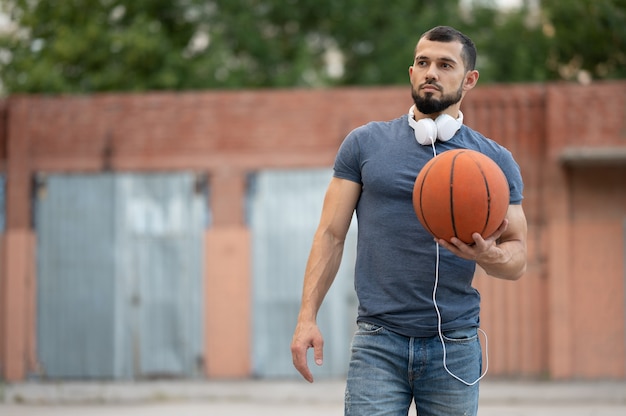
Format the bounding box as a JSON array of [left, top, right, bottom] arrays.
[[36, 173, 206, 379]]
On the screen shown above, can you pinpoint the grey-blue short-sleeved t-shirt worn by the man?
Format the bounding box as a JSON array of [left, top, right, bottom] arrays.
[[334, 115, 523, 337]]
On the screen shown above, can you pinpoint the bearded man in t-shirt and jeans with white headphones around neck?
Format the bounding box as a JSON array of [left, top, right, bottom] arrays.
[[291, 27, 527, 416]]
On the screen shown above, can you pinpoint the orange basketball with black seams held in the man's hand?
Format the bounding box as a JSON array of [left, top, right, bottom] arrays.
[[413, 149, 509, 244]]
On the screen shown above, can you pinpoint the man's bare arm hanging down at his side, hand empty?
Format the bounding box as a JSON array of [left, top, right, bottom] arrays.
[[291, 178, 361, 382]]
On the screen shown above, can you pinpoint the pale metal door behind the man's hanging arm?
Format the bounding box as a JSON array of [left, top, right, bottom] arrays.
[[249, 169, 356, 377]]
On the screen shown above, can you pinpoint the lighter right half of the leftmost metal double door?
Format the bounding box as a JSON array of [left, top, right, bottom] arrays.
[[116, 173, 206, 378]]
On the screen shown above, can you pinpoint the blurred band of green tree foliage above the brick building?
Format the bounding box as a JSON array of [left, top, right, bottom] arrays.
[[0, 0, 626, 93]]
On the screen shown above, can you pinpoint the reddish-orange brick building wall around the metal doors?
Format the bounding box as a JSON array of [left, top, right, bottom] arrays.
[[0, 81, 626, 380]]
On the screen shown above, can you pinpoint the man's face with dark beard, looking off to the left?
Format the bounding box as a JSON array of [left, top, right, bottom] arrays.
[[409, 39, 466, 114]]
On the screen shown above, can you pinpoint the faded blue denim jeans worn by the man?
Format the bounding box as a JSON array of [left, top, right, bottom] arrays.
[[344, 322, 482, 416]]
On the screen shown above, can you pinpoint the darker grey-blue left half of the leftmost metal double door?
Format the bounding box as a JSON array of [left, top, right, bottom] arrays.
[[36, 175, 116, 378]]
